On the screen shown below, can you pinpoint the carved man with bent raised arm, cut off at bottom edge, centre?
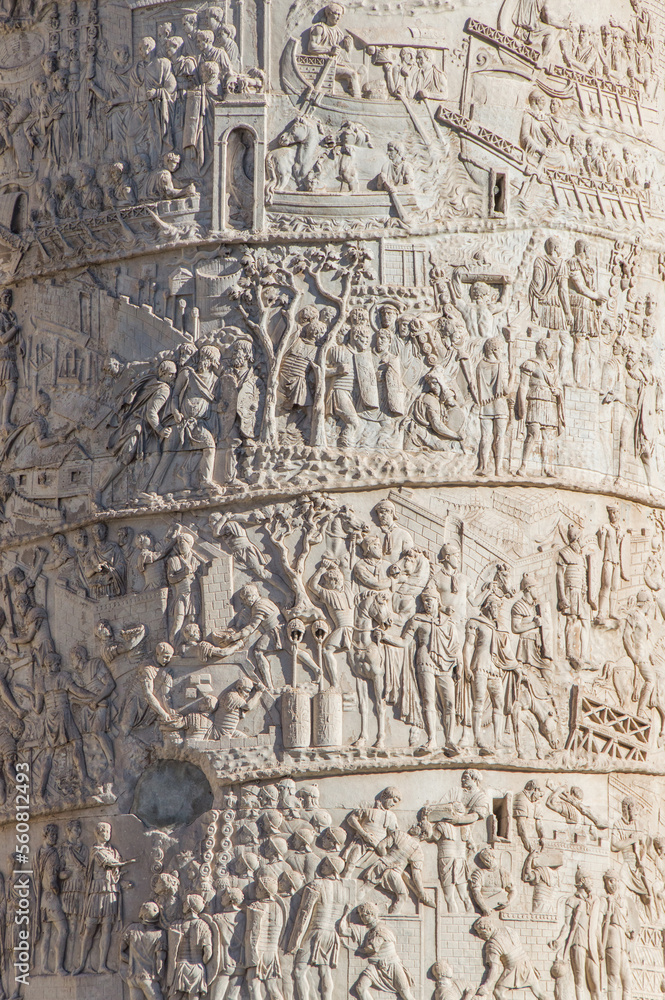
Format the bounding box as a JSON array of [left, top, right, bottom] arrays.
[[340, 903, 414, 1000]]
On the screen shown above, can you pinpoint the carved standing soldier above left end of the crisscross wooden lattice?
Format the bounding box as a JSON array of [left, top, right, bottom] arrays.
[[556, 524, 596, 666]]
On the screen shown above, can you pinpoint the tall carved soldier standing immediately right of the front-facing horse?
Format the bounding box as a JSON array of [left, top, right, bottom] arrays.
[[402, 587, 462, 757]]
